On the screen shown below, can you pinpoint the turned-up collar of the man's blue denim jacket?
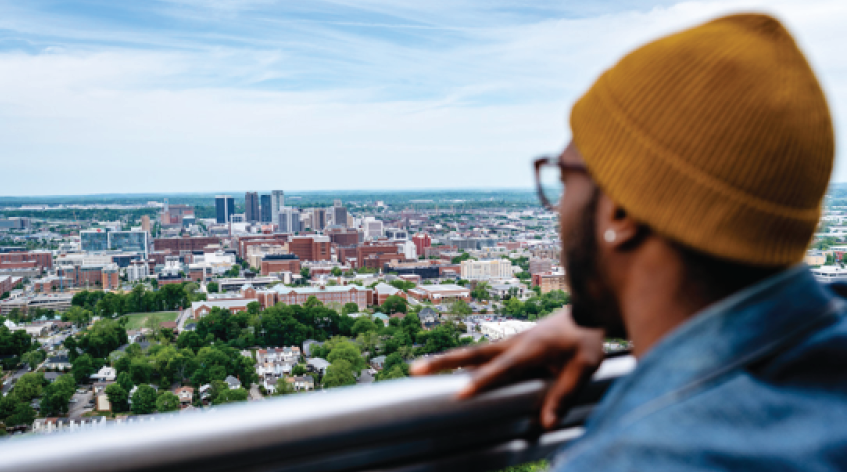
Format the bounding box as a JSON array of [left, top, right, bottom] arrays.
[[589, 264, 839, 434]]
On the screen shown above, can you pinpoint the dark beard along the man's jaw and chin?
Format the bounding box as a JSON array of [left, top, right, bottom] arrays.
[[562, 188, 627, 338]]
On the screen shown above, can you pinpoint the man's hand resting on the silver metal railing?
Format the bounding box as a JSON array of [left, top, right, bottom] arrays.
[[410, 310, 604, 429]]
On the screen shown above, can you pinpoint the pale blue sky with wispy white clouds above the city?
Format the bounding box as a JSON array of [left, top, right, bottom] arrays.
[[0, 0, 848, 196]]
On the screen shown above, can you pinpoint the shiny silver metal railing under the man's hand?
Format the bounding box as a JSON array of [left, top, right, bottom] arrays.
[[0, 356, 635, 472]]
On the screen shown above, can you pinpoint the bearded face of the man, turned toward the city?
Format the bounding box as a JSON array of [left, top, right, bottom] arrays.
[[559, 143, 626, 338]]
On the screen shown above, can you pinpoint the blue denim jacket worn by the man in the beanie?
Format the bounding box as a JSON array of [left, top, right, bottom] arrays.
[[554, 265, 848, 472]]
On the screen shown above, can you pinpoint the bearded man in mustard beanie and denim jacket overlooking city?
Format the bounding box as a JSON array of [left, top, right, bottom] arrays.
[[412, 15, 846, 471]]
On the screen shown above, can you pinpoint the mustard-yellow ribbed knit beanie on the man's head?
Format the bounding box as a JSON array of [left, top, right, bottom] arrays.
[[571, 14, 834, 266]]
